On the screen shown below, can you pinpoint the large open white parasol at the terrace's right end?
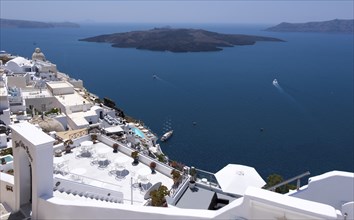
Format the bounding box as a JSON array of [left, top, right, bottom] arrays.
[[215, 164, 266, 195]]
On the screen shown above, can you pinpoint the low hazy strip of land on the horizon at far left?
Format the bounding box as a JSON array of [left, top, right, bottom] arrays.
[[0, 18, 80, 28]]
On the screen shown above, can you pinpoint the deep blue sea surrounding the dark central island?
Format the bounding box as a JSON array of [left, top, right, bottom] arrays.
[[0, 24, 354, 178]]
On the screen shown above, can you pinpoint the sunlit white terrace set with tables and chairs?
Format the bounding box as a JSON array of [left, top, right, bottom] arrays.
[[53, 136, 173, 205]]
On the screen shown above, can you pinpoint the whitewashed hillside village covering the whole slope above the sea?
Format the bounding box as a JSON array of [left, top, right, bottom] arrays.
[[0, 48, 354, 219]]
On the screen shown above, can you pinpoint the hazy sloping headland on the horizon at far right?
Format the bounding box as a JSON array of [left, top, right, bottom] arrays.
[[266, 19, 354, 33]]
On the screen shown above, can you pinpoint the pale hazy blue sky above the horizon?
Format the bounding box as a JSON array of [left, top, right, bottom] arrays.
[[0, 0, 354, 24]]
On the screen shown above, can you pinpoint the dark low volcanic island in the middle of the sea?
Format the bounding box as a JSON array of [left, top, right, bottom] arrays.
[[80, 27, 283, 52]]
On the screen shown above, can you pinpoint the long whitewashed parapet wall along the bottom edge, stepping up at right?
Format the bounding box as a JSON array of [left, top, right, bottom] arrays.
[[38, 187, 337, 220]]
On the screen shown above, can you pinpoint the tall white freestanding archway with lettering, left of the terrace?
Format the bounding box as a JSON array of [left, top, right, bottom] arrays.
[[10, 122, 55, 219]]
